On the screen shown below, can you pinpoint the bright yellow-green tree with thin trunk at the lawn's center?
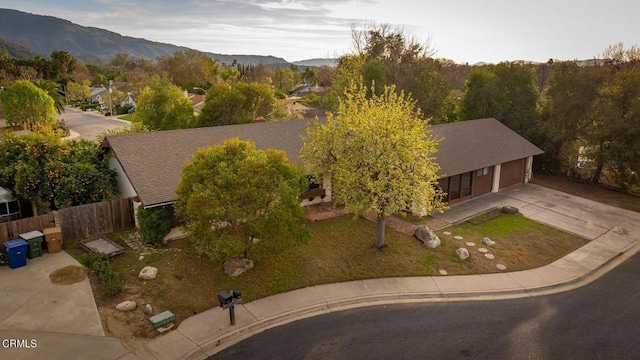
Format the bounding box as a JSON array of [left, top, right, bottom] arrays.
[[301, 87, 441, 248]]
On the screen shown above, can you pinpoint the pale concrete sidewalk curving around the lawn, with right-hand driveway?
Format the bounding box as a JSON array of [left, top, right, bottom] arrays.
[[0, 184, 640, 359]]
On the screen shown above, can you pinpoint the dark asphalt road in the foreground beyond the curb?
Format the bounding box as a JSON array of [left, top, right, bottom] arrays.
[[209, 254, 640, 359]]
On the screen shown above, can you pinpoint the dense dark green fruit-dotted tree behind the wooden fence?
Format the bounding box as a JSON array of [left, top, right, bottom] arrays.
[[0, 133, 118, 209]]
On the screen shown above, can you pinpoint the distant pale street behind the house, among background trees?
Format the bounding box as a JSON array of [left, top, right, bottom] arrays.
[[58, 107, 129, 140]]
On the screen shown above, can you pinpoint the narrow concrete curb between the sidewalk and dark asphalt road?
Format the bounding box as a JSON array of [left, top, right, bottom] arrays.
[[177, 240, 640, 360]]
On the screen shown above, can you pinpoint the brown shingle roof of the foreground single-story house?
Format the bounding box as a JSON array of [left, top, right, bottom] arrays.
[[107, 119, 542, 206]]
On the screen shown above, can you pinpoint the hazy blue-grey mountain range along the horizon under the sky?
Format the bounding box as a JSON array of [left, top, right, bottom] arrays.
[[0, 9, 335, 67]]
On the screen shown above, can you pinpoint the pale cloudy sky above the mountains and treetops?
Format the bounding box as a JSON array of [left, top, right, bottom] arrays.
[[0, 0, 640, 64]]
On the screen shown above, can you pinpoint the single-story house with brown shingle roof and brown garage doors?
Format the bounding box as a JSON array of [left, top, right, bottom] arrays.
[[103, 118, 543, 212]]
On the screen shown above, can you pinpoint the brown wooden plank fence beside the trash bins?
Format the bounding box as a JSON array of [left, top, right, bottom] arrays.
[[0, 199, 135, 243]]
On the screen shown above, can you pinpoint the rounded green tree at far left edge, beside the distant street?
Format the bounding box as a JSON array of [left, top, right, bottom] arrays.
[[0, 80, 56, 129]]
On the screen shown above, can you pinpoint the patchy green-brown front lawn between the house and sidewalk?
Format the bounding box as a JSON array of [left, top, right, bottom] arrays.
[[87, 211, 587, 337]]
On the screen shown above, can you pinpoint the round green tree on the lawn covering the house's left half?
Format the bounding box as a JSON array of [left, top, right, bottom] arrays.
[[175, 139, 309, 260]]
